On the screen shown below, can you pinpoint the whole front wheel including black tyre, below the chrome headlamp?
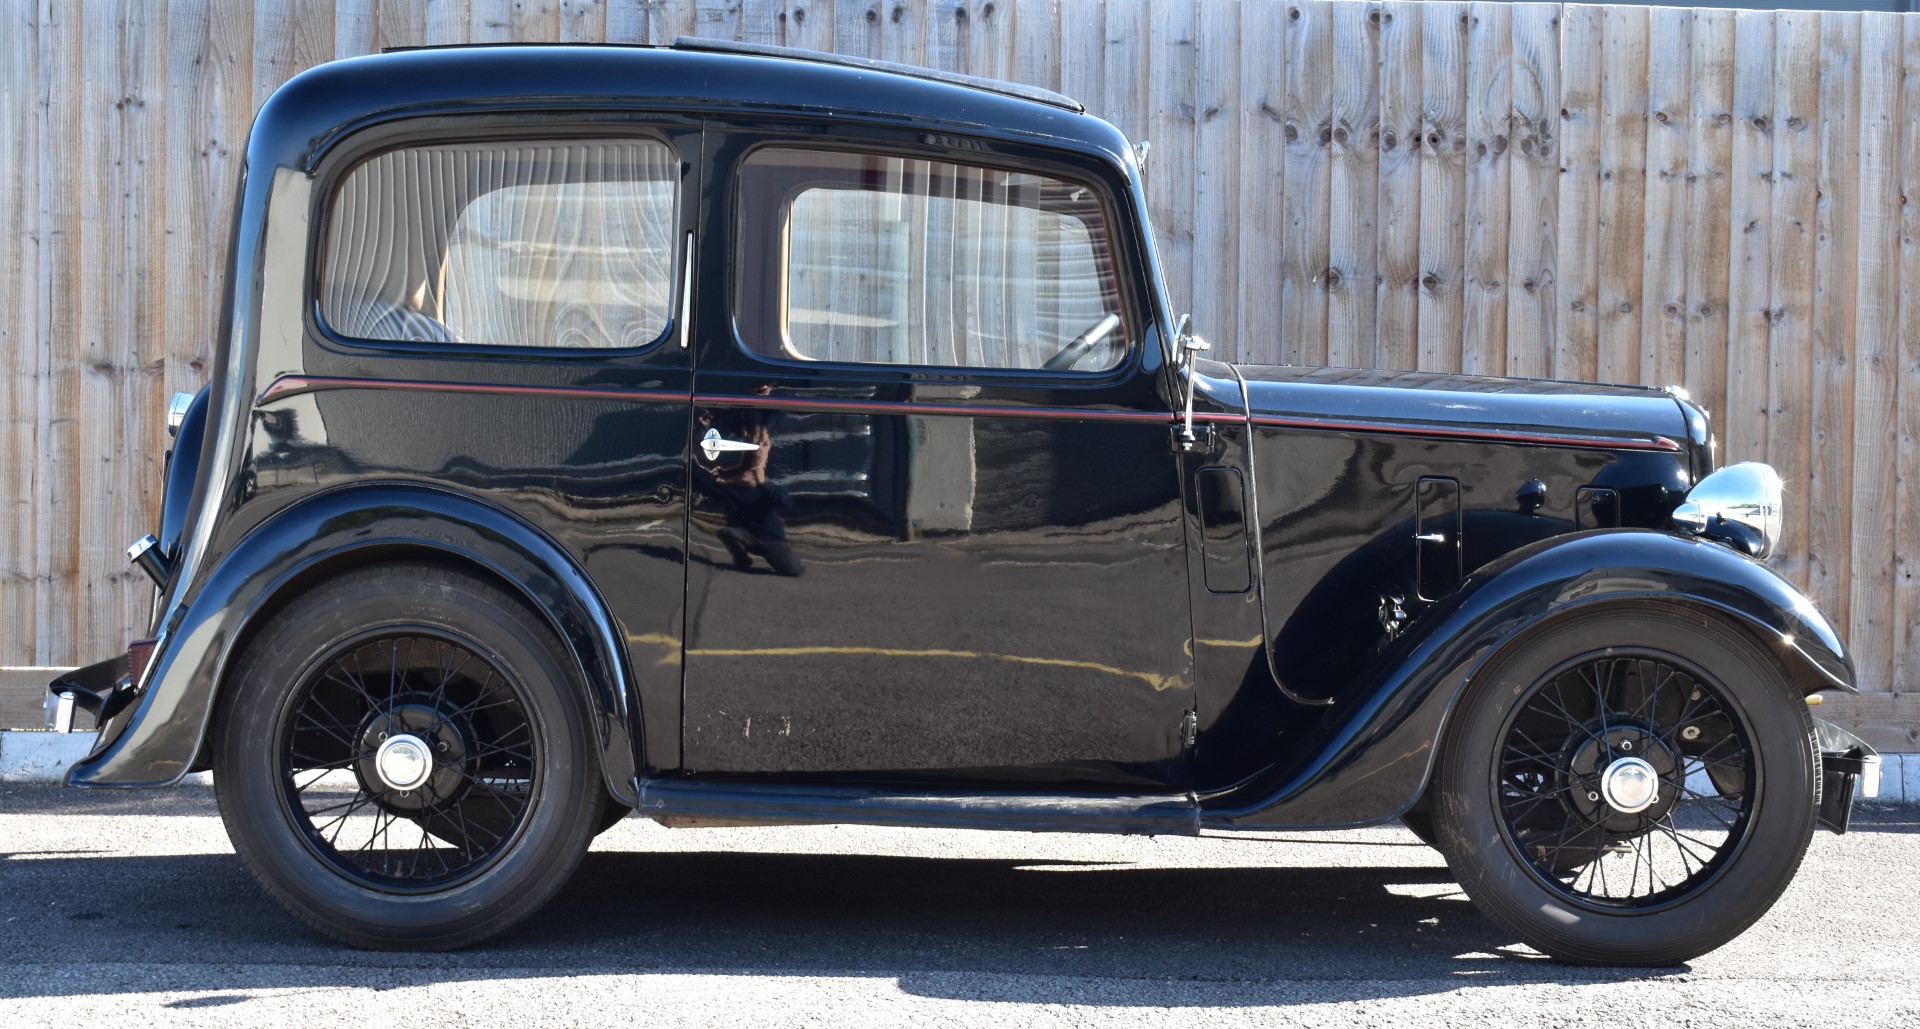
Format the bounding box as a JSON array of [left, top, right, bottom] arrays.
[[1432, 609, 1818, 966]]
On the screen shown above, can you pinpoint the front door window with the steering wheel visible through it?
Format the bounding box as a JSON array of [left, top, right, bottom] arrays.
[[735, 148, 1131, 372]]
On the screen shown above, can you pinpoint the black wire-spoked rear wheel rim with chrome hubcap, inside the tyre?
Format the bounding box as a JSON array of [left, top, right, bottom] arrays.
[[276, 626, 541, 893]]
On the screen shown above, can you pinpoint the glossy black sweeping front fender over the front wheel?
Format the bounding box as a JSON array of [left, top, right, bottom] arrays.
[[1202, 530, 1855, 829]]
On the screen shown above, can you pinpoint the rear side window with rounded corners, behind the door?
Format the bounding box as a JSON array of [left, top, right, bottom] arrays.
[[319, 140, 680, 349]]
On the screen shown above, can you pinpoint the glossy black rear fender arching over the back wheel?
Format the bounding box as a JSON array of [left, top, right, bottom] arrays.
[[67, 484, 639, 804]]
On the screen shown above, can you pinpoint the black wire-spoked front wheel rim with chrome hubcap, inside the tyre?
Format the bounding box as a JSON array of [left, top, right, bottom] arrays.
[[1494, 647, 1755, 910]]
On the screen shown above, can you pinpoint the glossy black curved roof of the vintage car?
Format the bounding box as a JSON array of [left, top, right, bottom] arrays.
[[253, 38, 1127, 167]]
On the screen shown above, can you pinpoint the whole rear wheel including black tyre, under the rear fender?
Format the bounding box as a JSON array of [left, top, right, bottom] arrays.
[[213, 564, 607, 950]]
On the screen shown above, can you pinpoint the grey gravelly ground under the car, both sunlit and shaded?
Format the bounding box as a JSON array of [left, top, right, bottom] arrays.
[[0, 785, 1920, 1029]]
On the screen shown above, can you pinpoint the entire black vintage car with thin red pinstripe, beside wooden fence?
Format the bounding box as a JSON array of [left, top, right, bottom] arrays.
[[52, 40, 1878, 964]]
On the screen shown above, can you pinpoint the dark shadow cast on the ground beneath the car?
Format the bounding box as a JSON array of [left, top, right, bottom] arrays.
[[0, 850, 1681, 1006]]
